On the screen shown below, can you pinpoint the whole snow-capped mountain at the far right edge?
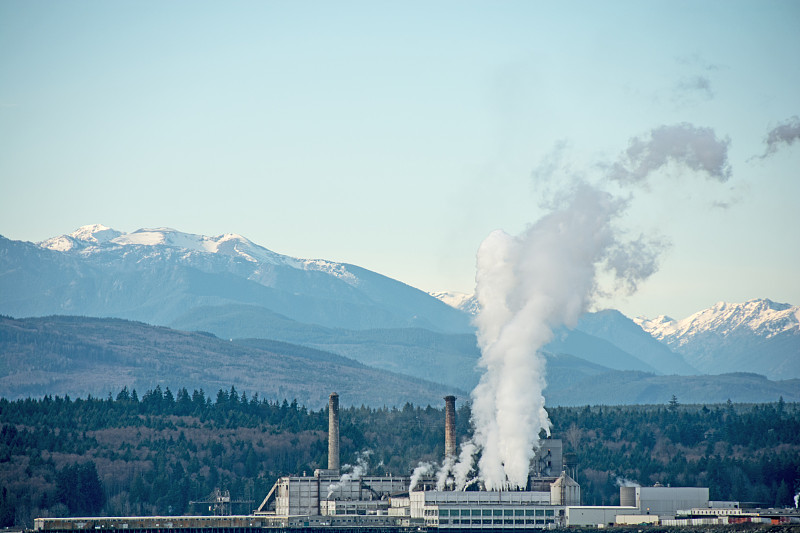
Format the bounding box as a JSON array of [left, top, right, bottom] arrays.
[[636, 299, 800, 379]]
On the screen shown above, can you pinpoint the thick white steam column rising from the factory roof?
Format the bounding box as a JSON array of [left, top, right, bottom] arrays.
[[472, 184, 634, 490]]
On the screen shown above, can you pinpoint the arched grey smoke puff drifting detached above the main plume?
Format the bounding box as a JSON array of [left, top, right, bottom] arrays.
[[608, 123, 731, 185]]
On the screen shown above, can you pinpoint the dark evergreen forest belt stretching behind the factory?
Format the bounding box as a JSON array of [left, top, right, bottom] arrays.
[[0, 387, 800, 526]]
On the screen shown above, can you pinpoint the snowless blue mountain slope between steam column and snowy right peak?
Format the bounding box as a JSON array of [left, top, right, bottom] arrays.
[[576, 309, 699, 375]]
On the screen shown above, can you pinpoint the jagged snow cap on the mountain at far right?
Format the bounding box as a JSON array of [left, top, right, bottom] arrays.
[[634, 299, 800, 343]]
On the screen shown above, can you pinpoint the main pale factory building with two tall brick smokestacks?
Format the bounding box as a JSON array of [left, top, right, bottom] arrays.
[[248, 393, 580, 530]]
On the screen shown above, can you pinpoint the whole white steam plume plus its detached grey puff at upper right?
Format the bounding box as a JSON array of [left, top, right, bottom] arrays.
[[446, 124, 730, 490]]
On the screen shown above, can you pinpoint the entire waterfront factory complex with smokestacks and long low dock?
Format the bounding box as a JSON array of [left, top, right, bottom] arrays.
[[34, 393, 800, 533]]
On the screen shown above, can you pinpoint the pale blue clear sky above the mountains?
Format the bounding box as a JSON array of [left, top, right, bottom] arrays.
[[0, 0, 800, 318]]
